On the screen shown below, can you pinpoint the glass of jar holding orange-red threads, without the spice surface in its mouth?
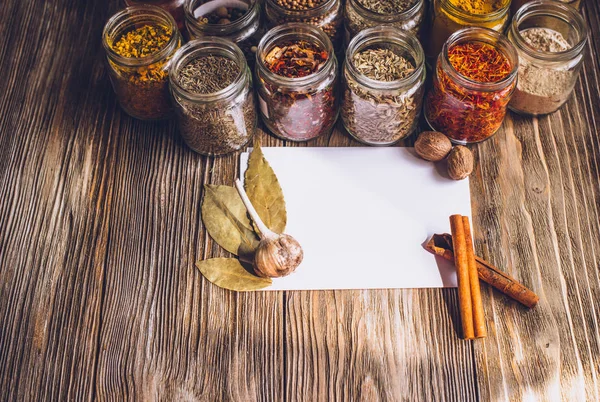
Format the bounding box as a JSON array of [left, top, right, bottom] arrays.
[[425, 28, 518, 145]]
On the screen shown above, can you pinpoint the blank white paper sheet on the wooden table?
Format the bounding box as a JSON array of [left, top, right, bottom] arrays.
[[240, 147, 471, 290]]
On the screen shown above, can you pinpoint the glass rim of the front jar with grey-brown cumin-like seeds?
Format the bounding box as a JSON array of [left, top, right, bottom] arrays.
[[169, 36, 248, 102]]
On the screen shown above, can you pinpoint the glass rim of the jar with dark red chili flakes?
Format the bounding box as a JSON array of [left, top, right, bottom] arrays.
[[255, 22, 337, 88]]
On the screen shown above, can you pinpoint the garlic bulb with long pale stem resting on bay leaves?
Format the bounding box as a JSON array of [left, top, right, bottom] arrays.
[[235, 179, 304, 278]]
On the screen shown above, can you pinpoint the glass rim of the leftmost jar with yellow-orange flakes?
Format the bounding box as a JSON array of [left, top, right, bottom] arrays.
[[102, 4, 179, 67]]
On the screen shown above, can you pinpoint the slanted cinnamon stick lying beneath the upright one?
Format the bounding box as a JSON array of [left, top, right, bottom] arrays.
[[425, 233, 539, 308]]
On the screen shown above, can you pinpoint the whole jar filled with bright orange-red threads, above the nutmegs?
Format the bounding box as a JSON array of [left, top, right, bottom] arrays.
[[425, 28, 519, 144]]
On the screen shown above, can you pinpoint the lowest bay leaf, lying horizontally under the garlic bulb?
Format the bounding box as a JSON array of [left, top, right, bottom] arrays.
[[196, 258, 273, 291]]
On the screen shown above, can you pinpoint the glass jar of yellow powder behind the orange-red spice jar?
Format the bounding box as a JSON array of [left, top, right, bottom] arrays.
[[426, 0, 510, 59]]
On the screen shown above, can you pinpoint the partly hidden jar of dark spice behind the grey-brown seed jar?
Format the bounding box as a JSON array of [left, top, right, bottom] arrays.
[[185, 0, 264, 67]]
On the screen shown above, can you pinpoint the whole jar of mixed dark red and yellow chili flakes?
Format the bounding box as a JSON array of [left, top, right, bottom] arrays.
[[255, 23, 338, 141]]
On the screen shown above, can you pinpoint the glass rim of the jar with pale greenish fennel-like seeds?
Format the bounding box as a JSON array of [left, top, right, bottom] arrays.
[[344, 26, 425, 89]]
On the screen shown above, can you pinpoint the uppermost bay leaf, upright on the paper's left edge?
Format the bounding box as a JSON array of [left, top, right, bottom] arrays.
[[244, 142, 287, 233]]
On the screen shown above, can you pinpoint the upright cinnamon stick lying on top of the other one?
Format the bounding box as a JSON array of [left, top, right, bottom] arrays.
[[450, 215, 475, 339]]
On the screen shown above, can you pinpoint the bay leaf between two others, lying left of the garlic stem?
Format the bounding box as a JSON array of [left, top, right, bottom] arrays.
[[202, 184, 259, 261]]
